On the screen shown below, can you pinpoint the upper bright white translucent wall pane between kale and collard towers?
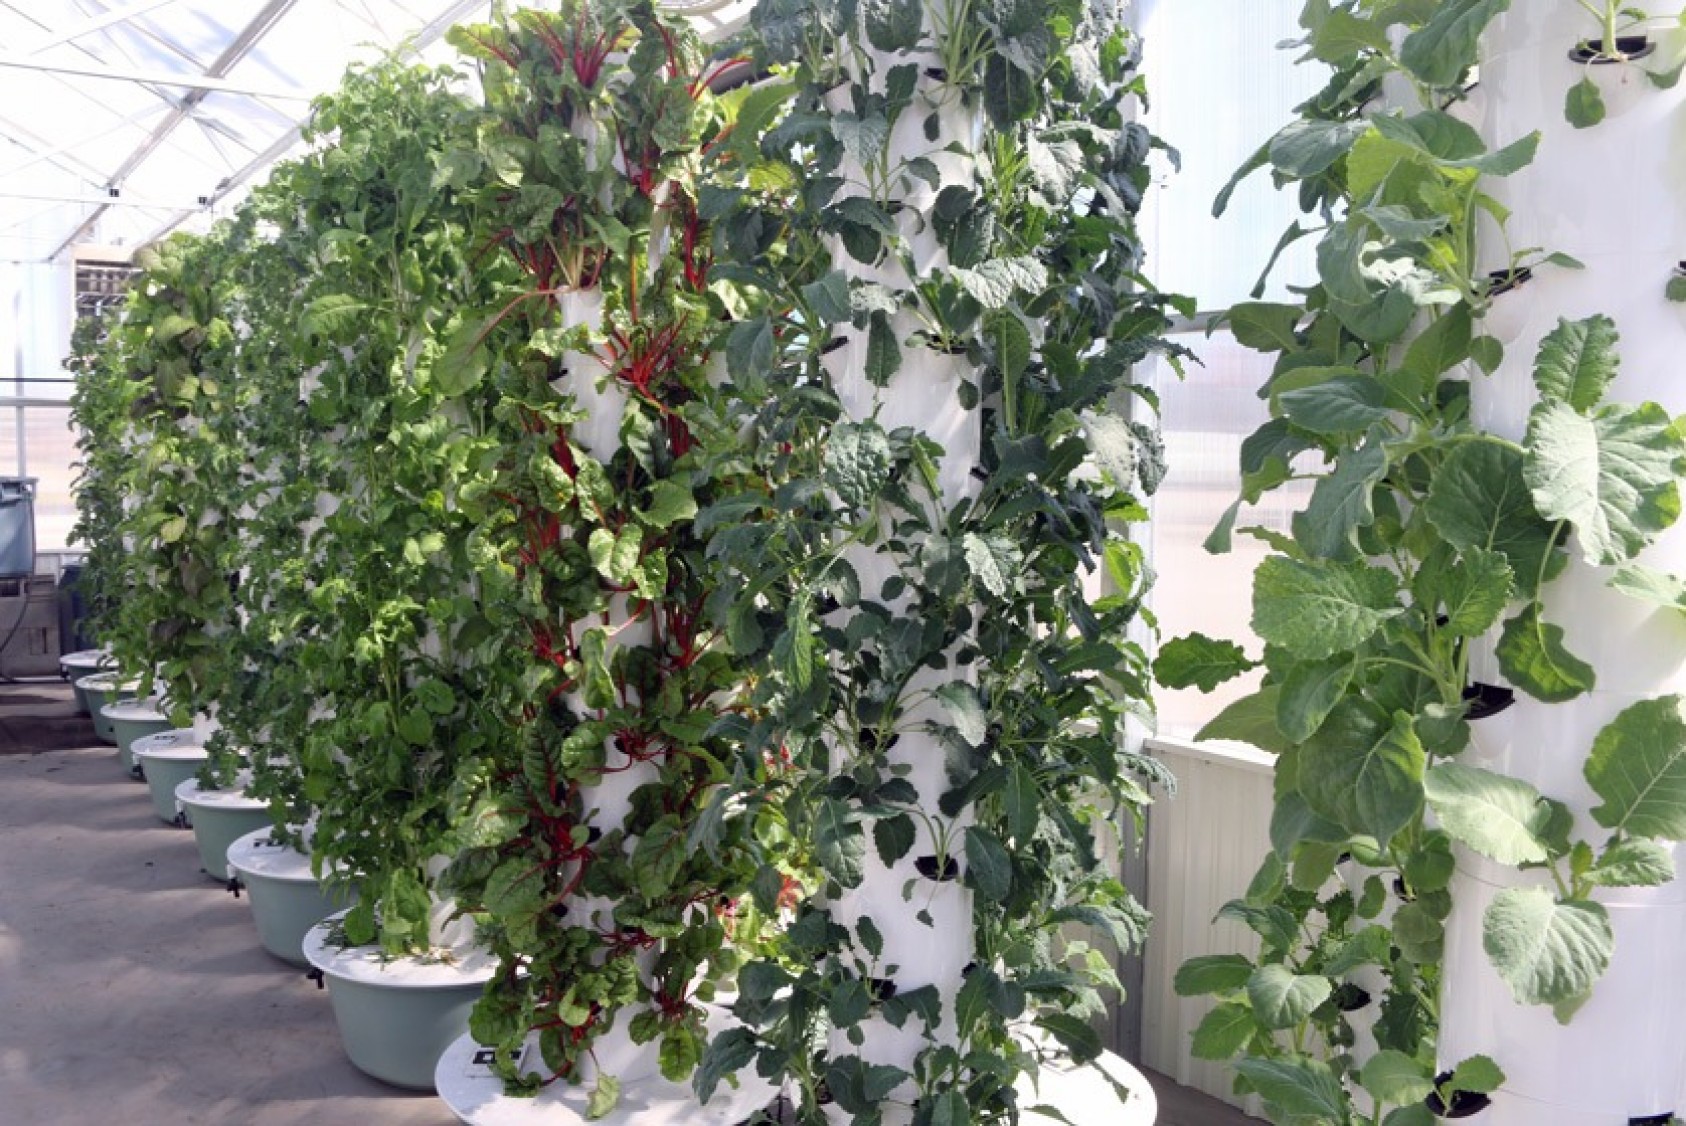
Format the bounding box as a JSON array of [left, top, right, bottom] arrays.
[[1140, 0, 1329, 308]]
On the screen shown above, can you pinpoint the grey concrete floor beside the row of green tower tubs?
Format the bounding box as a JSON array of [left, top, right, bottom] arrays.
[[0, 683, 1254, 1126]]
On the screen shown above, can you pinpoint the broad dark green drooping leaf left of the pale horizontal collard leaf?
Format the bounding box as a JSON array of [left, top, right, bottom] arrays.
[[1300, 698, 1426, 846]]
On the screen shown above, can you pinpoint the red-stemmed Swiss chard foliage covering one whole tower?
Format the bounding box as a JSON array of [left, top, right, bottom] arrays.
[[447, 2, 789, 1116]]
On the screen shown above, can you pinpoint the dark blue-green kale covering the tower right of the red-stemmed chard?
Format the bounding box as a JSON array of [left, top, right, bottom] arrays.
[[695, 5, 1167, 1123]]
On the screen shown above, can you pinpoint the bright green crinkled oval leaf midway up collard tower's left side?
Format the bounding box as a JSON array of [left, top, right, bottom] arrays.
[[1253, 555, 1403, 661]]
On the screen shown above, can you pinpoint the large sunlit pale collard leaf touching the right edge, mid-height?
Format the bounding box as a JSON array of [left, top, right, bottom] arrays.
[[1522, 403, 1686, 565]]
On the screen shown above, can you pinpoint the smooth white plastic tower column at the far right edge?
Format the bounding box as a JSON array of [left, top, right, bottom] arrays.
[[1440, 0, 1686, 1126]]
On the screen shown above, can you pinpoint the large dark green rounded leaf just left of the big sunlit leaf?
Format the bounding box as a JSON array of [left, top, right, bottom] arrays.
[[1425, 438, 1561, 598]]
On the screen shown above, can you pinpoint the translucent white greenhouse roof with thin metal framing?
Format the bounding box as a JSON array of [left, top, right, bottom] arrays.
[[0, 0, 747, 263]]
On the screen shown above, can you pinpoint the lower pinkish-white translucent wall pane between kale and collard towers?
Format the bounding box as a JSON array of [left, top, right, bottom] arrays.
[[1148, 334, 1310, 735]]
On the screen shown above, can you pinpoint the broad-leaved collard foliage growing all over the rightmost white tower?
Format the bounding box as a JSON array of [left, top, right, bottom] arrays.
[[1155, 3, 1686, 1123]]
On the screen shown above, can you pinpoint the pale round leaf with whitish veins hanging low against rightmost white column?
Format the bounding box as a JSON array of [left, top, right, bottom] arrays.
[[1482, 888, 1615, 1005]]
